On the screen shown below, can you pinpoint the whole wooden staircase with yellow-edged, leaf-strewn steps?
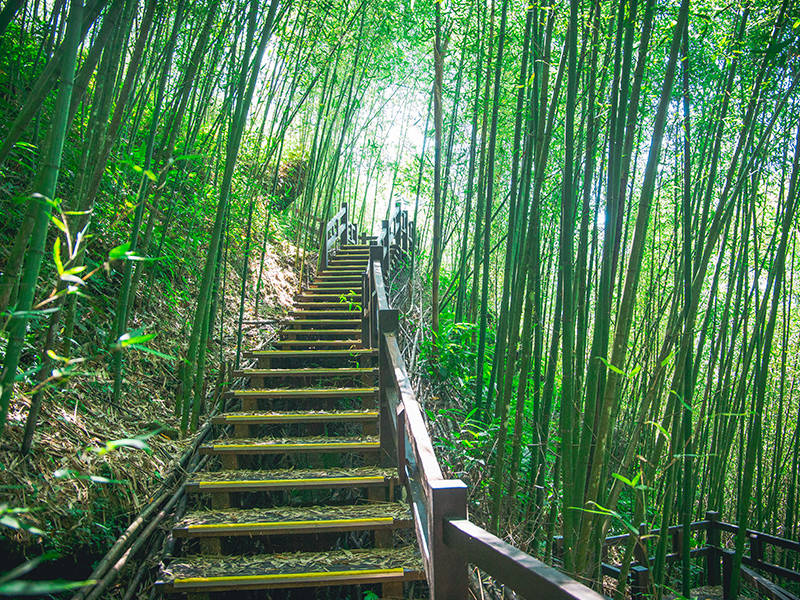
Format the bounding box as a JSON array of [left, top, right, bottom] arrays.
[[158, 245, 425, 600]]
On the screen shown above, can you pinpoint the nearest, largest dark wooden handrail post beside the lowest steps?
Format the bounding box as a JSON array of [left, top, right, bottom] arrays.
[[428, 479, 469, 600]]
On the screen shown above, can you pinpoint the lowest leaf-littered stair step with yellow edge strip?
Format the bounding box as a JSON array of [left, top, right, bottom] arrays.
[[156, 546, 425, 593]]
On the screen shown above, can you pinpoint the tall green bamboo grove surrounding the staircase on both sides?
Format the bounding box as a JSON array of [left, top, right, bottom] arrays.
[[0, 0, 800, 597]]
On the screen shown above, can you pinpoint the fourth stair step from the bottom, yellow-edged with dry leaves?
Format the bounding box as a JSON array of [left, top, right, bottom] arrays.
[[200, 435, 381, 456]]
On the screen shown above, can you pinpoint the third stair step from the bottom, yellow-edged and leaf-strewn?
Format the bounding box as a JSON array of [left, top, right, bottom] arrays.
[[186, 467, 397, 494]]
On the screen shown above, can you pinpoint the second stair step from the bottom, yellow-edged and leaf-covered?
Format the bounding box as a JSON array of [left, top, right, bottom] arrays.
[[172, 502, 413, 538]]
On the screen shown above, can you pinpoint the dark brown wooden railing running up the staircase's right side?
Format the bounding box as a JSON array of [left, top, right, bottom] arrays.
[[354, 205, 603, 600]]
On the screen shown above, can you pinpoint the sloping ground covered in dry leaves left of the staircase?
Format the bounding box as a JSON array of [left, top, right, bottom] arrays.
[[0, 223, 314, 579]]
